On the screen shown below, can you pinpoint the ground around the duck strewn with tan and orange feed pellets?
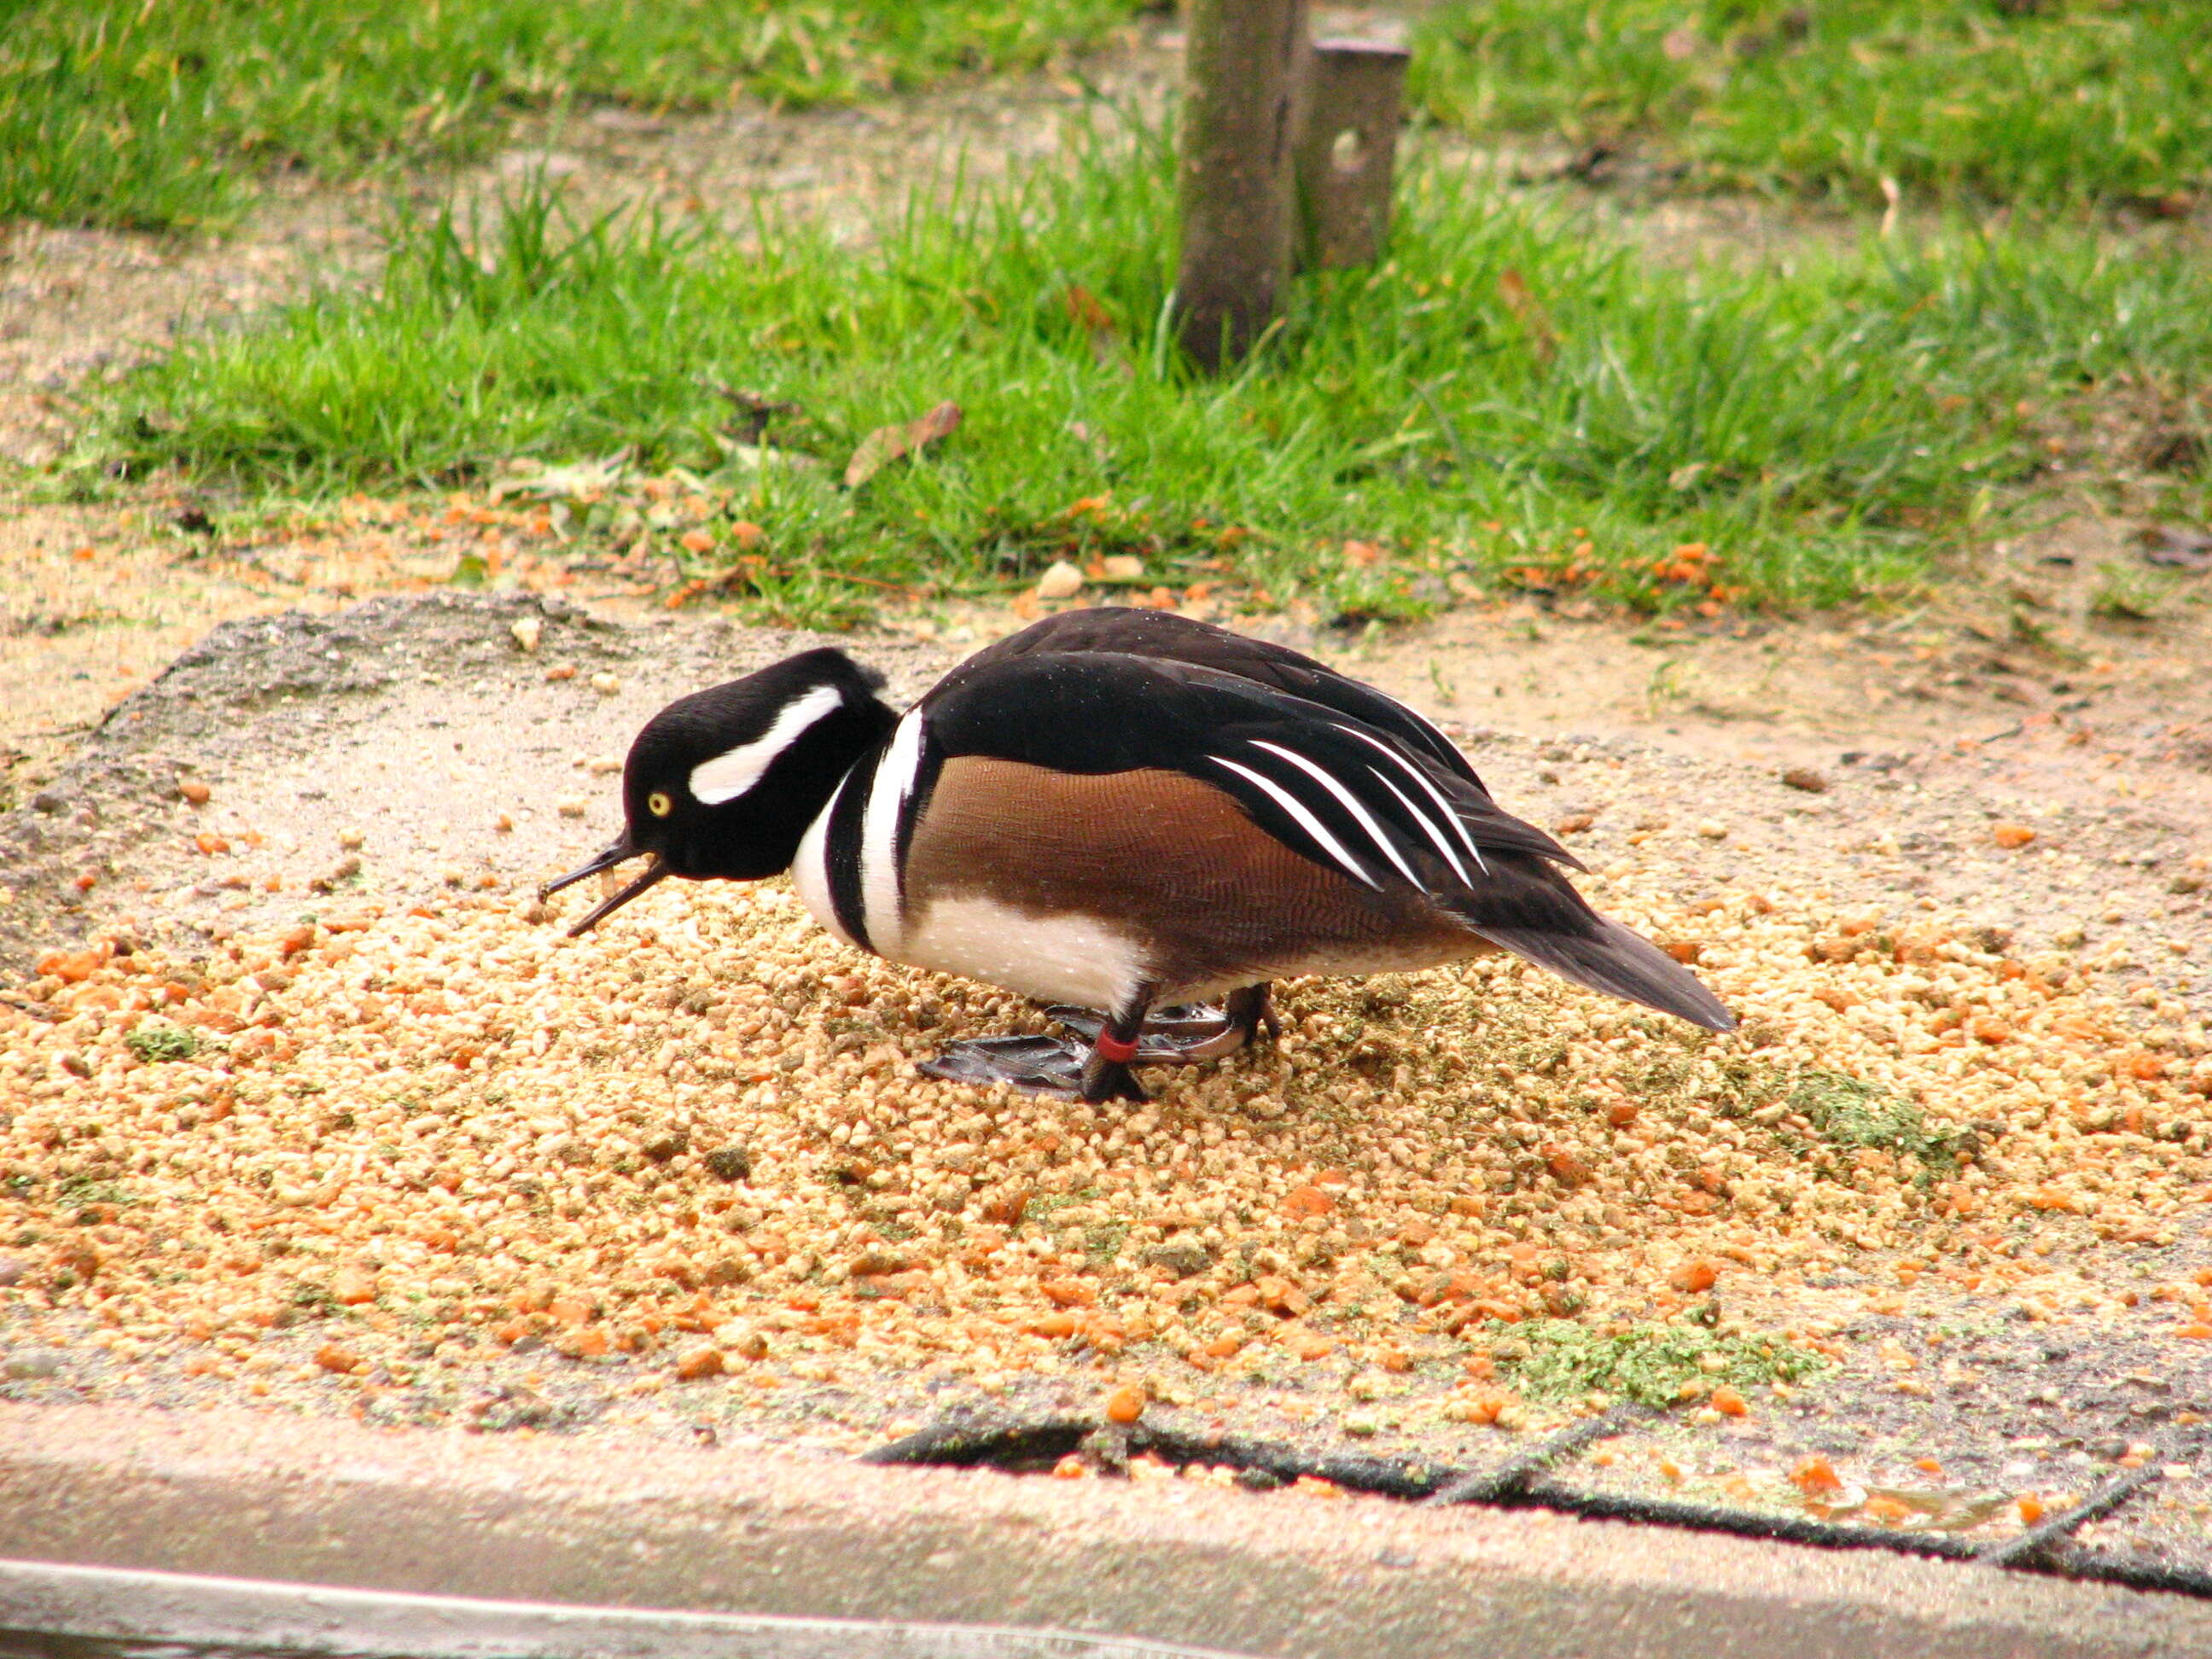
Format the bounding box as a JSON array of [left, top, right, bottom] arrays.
[[0, 595, 2212, 1559]]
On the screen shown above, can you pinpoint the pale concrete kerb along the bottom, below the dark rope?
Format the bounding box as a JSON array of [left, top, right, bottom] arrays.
[[0, 1405, 2212, 1659]]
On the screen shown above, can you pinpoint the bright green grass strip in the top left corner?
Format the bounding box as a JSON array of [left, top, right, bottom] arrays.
[[0, 0, 1139, 230]]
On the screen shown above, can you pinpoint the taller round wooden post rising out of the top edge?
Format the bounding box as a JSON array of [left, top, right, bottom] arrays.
[[1174, 0, 1309, 370]]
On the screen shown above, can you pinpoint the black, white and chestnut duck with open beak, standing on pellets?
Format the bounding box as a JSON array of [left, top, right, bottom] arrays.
[[542, 608, 1734, 1102]]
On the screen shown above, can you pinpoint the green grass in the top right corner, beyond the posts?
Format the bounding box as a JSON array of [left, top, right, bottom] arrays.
[[1413, 0, 2212, 208]]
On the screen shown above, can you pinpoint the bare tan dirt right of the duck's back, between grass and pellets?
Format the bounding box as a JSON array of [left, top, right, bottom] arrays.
[[1336, 520, 2212, 809]]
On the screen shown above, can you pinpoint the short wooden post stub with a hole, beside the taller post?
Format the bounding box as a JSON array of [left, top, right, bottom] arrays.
[[1299, 40, 1409, 270]]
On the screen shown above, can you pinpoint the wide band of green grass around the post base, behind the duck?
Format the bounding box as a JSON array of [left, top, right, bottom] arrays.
[[81, 115, 2212, 621]]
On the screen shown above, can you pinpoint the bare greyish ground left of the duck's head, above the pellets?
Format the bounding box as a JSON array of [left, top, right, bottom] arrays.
[[0, 591, 942, 964]]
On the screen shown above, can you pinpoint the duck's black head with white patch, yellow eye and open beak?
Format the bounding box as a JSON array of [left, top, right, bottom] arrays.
[[538, 646, 898, 938]]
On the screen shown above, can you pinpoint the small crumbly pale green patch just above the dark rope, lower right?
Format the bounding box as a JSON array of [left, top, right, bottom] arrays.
[[1487, 1318, 1830, 1407]]
